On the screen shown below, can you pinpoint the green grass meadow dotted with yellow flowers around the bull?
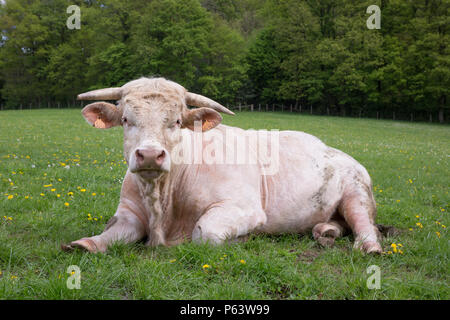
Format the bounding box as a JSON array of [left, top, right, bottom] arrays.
[[0, 110, 450, 299]]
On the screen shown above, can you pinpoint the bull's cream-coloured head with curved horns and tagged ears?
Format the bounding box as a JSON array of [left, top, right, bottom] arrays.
[[78, 78, 234, 180]]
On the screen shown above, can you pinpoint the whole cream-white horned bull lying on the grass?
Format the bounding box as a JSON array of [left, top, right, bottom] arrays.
[[62, 78, 382, 253]]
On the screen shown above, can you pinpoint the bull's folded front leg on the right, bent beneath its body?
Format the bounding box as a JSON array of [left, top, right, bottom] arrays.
[[192, 205, 267, 244]]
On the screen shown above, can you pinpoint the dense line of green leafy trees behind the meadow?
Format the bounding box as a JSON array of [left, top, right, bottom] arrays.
[[0, 0, 450, 122]]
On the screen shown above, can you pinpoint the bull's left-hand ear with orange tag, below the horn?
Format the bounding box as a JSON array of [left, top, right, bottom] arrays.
[[81, 102, 122, 129]]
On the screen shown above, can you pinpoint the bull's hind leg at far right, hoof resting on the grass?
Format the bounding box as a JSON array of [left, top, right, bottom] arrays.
[[338, 186, 382, 253]]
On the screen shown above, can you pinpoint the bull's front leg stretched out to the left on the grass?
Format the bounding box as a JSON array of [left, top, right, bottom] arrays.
[[61, 203, 146, 253]]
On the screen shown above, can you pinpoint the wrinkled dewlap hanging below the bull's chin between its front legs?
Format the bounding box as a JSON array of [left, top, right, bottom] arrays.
[[138, 172, 170, 246]]
